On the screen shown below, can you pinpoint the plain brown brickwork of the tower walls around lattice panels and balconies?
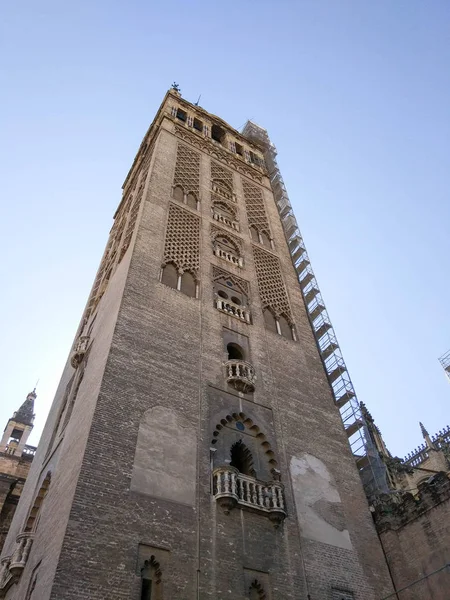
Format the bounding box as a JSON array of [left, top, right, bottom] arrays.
[[0, 93, 392, 600]]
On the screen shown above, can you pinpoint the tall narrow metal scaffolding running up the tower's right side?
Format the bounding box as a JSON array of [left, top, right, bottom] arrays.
[[242, 121, 390, 499]]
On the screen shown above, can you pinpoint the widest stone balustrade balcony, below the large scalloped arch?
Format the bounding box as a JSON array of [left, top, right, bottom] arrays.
[[213, 465, 286, 527]]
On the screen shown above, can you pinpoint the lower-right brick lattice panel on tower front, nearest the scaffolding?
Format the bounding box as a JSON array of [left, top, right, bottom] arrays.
[[253, 246, 292, 324]]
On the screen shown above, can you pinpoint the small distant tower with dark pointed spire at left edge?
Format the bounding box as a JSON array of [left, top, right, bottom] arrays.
[[0, 390, 36, 551]]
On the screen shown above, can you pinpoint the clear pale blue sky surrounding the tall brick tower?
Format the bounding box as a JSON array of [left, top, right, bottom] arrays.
[[0, 0, 450, 456]]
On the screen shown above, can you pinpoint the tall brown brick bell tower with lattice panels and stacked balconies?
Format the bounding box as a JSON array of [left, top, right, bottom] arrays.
[[0, 86, 392, 600]]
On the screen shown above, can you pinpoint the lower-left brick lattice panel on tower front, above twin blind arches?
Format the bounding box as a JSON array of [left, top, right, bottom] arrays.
[[163, 204, 200, 277]]
